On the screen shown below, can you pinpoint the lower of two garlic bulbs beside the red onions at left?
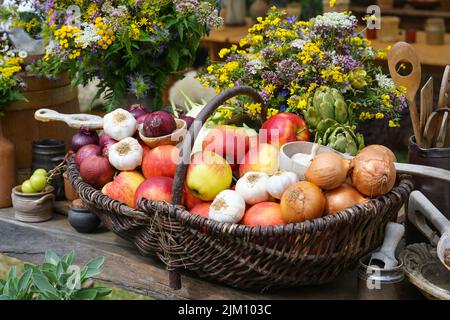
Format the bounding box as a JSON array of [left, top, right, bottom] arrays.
[[108, 137, 144, 171]]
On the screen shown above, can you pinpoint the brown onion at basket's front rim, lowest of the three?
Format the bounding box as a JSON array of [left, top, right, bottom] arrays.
[[280, 181, 326, 223]]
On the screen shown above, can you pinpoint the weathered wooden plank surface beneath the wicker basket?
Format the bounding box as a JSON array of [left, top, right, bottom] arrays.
[[0, 208, 421, 299]]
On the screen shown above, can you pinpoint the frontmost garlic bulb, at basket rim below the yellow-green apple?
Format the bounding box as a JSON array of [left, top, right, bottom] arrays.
[[209, 190, 245, 223]]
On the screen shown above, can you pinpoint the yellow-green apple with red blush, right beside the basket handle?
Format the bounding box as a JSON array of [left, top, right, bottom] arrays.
[[186, 151, 233, 201]]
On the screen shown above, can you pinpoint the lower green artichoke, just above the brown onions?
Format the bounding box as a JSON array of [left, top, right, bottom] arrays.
[[316, 122, 364, 156]]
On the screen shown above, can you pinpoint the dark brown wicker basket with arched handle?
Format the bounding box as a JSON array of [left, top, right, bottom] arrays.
[[68, 87, 412, 291]]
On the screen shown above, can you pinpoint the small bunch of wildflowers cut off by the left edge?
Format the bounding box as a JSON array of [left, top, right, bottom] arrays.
[[0, 32, 26, 109]]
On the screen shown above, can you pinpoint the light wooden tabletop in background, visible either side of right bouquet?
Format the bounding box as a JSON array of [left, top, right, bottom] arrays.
[[202, 25, 450, 67]]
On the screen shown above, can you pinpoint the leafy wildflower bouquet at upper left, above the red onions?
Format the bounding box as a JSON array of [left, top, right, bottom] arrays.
[[23, 0, 222, 109]]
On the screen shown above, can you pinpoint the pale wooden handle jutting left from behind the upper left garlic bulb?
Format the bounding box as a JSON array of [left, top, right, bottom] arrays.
[[34, 109, 103, 130]]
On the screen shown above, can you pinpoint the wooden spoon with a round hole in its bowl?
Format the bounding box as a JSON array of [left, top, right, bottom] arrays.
[[387, 42, 422, 146]]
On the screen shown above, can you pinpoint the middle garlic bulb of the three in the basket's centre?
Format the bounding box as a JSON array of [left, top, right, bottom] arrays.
[[236, 172, 269, 204]]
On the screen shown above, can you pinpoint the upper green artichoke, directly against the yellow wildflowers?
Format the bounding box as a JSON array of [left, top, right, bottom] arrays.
[[304, 87, 353, 130]]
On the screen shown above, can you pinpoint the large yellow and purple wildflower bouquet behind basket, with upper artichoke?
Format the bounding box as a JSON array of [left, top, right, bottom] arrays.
[[200, 8, 406, 151]]
